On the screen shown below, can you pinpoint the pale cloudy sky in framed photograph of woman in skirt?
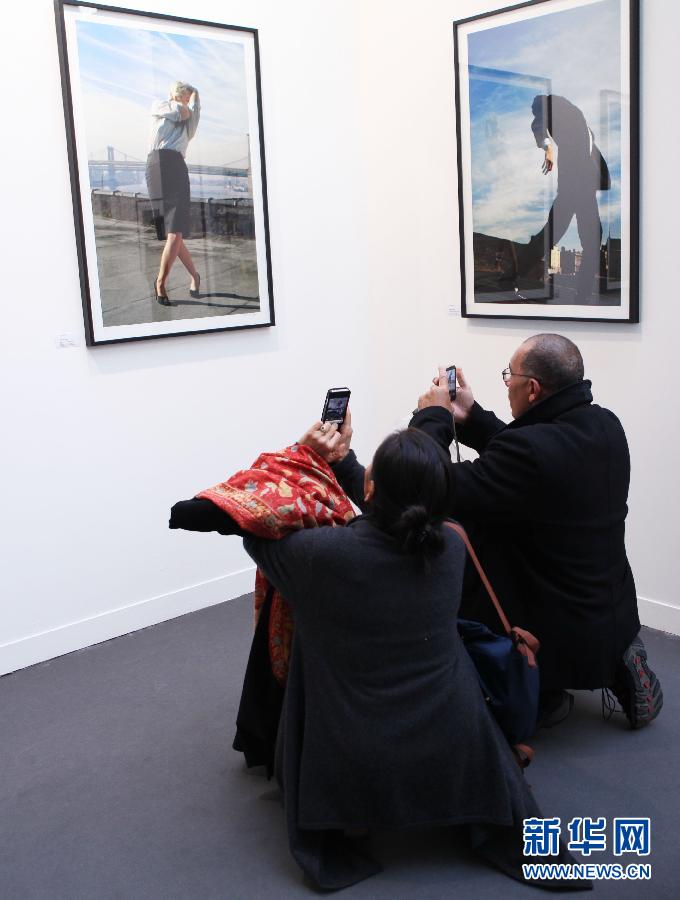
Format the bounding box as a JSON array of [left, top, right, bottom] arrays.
[[76, 21, 249, 165]]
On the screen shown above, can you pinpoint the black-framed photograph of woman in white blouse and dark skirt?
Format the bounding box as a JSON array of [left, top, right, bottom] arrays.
[[55, 0, 274, 345]]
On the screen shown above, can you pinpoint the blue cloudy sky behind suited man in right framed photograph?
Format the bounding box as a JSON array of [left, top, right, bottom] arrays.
[[467, 0, 621, 247]]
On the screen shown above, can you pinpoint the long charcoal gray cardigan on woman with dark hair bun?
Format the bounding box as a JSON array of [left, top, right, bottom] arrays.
[[244, 517, 583, 888]]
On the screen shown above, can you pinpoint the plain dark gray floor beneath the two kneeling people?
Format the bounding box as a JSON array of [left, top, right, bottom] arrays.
[[0, 597, 680, 900]]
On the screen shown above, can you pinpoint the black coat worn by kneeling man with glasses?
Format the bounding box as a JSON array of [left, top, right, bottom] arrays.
[[412, 381, 640, 689]]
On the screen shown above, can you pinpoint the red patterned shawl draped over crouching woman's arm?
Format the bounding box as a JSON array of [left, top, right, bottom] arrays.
[[197, 444, 355, 684]]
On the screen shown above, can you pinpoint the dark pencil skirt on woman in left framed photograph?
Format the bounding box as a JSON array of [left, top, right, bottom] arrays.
[[146, 150, 191, 241]]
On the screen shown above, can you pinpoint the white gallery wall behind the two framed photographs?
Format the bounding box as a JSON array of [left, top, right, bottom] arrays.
[[0, 0, 680, 672]]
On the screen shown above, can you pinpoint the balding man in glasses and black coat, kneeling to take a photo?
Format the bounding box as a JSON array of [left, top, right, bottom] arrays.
[[318, 334, 663, 728]]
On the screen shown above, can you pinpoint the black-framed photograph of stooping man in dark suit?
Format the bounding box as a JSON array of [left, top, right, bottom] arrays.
[[454, 0, 639, 322]]
